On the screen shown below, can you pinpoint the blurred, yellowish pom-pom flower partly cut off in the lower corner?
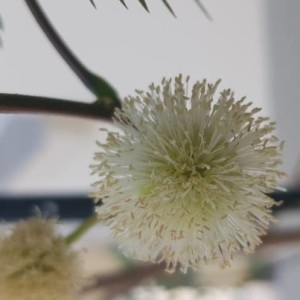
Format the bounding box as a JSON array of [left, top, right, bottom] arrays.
[[0, 217, 80, 300]]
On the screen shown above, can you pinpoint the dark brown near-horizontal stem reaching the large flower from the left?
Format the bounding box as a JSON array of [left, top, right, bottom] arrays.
[[0, 93, 114, 121]]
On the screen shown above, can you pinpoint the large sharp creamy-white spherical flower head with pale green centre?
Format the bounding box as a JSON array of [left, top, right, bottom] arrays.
[[92, 76, 282, 271]]
